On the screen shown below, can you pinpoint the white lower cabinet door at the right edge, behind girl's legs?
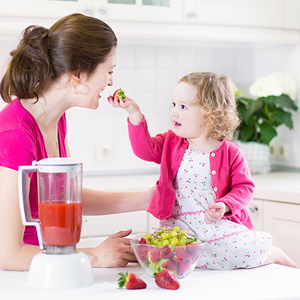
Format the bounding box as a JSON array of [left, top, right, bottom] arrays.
[[263, 201, 300, 266]]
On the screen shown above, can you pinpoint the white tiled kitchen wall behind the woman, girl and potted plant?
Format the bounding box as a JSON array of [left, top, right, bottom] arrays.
[[0, 33, 300, 175]]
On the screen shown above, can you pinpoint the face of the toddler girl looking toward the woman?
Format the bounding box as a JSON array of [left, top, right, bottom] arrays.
[[170, 82, 203, 139]]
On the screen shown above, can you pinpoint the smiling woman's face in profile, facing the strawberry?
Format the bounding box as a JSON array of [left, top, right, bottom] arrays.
[[76, 49, 116, 109]]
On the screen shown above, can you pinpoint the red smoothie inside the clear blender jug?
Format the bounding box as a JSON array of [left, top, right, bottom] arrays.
[[39, 201, 82, 246]]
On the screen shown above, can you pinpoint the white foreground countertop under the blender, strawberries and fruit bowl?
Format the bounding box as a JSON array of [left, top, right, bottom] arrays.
[[0, 263, 300, 300]]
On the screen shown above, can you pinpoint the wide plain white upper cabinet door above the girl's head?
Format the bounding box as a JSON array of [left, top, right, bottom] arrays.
[[183, 0, 284, 28]]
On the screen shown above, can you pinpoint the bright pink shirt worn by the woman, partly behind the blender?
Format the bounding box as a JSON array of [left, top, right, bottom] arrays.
[[0, 99, 67, 245]]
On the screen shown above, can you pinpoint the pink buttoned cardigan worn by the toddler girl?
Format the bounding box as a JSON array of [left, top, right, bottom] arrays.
[[128, 118, 254, 229]]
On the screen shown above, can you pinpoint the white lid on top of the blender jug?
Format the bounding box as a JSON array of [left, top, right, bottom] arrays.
[[32, 157, 82, 173]]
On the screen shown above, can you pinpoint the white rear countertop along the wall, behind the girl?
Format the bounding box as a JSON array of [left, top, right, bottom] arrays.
[[83, 172, 300, 204]]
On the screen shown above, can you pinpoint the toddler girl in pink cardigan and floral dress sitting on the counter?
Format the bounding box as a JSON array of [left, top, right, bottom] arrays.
[[108, 72, 296, 269]]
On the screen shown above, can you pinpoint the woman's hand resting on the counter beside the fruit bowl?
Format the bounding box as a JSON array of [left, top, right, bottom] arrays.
[[83, 229, 136, 268]]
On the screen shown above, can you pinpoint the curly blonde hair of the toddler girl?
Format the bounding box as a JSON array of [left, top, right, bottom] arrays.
[[179, 72, 240, 141]]
